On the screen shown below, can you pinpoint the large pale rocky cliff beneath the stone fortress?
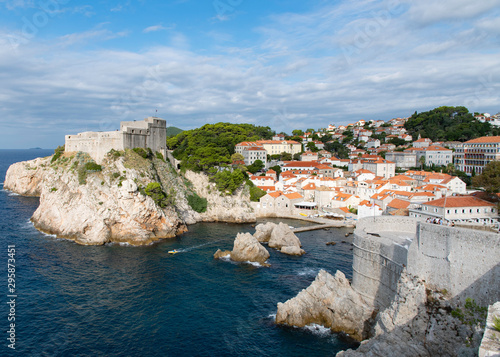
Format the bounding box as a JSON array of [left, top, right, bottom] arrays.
[[4, 150, 254, 245]]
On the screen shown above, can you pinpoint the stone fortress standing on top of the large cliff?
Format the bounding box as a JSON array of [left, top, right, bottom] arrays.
[[65, 117, 167, 164]]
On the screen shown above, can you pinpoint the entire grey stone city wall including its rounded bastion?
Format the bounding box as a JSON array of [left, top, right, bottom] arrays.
[[352, 216, 500, 309]]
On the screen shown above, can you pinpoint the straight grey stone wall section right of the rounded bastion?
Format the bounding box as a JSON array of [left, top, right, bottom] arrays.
[[408, 222, 500, 305]]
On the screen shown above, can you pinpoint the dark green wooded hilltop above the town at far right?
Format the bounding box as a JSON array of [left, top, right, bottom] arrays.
[[405, 107, 500, 141]]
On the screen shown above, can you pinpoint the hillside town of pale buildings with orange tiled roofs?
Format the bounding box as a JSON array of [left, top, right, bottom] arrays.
[[235, 114, 500, 231]]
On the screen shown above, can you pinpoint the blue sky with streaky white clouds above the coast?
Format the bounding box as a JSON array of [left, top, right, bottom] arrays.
[[0, 0, 500, 149]]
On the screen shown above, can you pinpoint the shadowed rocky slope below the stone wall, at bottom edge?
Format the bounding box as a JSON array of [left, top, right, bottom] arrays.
[[337, 272, 481, 357]]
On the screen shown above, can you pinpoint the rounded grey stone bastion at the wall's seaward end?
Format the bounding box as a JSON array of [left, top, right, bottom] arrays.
[[352, 216, 417, 310]]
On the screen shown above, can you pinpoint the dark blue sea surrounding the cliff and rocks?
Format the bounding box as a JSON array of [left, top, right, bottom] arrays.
[[0, 150, 356, 356]]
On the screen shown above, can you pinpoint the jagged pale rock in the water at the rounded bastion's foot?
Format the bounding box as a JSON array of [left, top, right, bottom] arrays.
[[276, 270, 374, 341]]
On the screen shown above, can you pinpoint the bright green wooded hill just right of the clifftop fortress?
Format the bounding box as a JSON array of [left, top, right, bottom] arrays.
[[167, 123, 274, 172]]
